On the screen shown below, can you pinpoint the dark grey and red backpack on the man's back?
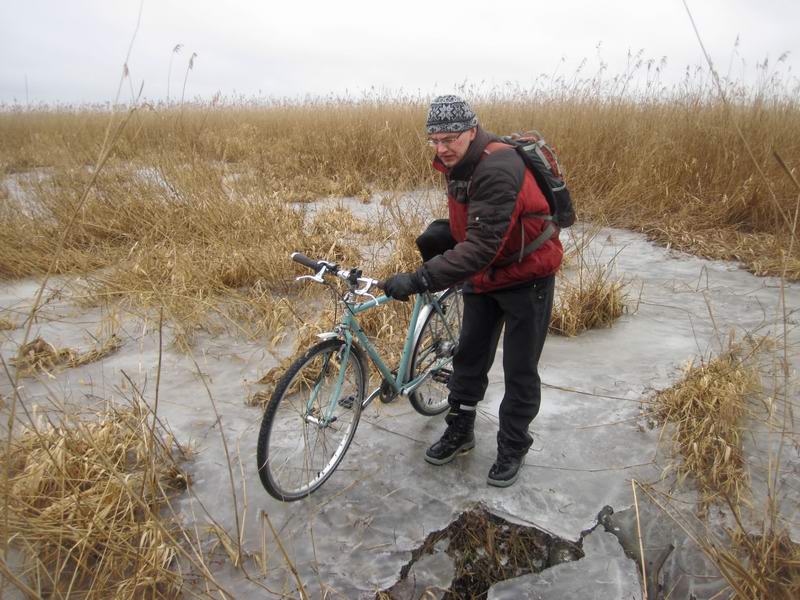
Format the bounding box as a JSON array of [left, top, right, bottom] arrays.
[[500, 130, 575, 229]]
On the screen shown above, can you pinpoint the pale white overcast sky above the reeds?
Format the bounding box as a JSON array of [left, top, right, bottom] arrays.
[[0, 0, 800, 104]]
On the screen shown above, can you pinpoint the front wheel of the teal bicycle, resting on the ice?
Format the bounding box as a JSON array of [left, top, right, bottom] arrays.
[[256, 339, 367, 502]]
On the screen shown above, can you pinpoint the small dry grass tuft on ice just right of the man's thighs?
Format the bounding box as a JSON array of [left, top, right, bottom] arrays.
[[550, 266, 627, 337]]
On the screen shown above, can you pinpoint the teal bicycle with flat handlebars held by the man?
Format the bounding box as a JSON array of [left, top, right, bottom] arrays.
[[256, 252, 463, 502]]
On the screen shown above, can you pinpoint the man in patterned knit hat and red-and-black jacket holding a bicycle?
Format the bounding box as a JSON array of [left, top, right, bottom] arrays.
[[384, 95, 564, 487]]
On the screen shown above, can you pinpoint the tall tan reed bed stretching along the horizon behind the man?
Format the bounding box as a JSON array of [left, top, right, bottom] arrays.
[[0, 69, 800, 278]]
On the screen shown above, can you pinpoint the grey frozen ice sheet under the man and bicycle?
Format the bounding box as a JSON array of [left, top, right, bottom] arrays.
[[0, 223, 800, 599]]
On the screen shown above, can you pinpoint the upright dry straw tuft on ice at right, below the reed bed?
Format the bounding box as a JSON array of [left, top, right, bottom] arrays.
[[654, 342, 760, 512]]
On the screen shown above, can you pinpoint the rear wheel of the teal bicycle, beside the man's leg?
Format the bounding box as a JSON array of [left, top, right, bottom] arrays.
[[409, 288, 464, 416]]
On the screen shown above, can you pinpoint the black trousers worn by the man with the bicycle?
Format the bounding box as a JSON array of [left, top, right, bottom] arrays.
[[448, 276, 555, 457]]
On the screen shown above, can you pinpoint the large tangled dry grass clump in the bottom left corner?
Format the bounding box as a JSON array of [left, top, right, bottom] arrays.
[[0, 398, 187, 600]]
